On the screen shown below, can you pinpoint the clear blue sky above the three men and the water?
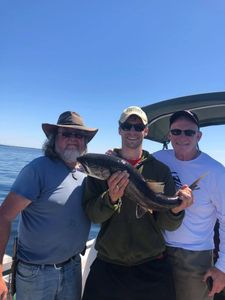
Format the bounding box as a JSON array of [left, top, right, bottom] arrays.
[[0, 0, 225, 164]]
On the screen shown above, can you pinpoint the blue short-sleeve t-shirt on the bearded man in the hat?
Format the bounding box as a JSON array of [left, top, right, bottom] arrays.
[[11, 157, 90, 264]]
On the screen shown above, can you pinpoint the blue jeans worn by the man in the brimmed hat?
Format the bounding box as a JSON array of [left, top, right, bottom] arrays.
[[16, 255, 81, 300]]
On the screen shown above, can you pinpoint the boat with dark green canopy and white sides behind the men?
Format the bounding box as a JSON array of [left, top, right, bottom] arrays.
[[3, 92, 225, 300]]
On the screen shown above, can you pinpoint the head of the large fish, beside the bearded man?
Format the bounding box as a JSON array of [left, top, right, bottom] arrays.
[[77, 153, 111, 180]]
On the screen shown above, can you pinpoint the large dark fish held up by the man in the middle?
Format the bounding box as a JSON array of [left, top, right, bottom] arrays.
[[77, 153, 182, 217]]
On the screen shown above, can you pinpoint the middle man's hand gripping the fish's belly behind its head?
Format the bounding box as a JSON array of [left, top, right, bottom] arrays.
[[107, 171, 129, 203]]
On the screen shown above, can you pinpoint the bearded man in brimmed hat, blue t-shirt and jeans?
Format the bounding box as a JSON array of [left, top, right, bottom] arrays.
[[0, 111, 97, 300]]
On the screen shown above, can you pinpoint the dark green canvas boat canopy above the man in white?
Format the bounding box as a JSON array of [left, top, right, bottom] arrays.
[[142, 92, 225, 145]]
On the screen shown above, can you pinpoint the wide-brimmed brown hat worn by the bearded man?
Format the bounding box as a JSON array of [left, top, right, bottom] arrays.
[[42, 111, 98, 143]]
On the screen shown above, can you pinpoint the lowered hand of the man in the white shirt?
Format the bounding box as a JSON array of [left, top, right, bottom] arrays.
[[203, 267, 225, 297]]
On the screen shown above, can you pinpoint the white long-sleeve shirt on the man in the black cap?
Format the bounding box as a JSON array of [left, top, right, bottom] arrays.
[[153, 150, 225, 272]]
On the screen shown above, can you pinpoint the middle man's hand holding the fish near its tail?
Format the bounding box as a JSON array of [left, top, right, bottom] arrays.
[[171, 184, 194, 214]]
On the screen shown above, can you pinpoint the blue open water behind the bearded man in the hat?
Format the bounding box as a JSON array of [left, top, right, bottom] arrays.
[[0, 145, 98, 255]]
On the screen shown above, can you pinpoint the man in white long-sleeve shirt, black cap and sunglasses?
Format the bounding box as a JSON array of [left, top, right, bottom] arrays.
[[154, 110, 225, 300]]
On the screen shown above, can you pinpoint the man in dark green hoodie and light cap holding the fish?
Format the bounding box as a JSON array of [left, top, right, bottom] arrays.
[[83, 106, 193, 300]]
